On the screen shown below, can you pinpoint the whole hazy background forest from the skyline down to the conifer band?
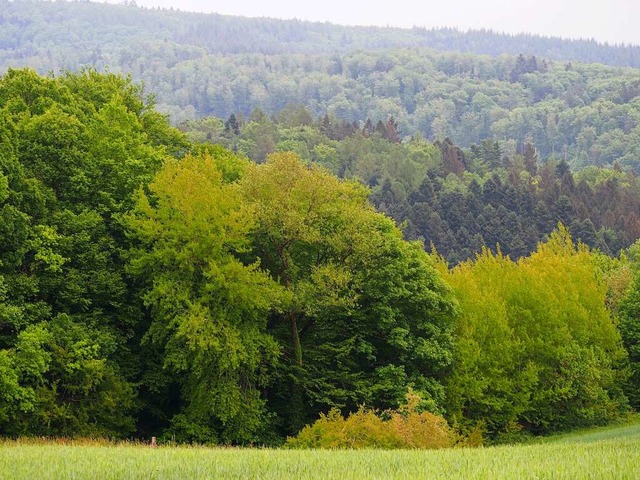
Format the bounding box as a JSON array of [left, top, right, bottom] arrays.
[[0, 0, 640, 171]]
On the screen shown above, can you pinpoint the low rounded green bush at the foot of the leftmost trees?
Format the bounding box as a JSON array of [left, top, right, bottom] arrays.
[[0, 314, 134, 437]]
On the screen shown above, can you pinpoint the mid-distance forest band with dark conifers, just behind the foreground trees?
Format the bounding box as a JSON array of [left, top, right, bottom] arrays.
[[180, 109, 640, 264]]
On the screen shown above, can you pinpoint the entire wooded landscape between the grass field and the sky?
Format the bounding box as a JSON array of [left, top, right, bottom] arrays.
[[0, 0, 640, 446]]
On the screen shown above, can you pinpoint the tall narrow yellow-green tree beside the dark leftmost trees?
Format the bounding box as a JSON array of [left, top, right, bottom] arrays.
[[127, 152, 278, 442]]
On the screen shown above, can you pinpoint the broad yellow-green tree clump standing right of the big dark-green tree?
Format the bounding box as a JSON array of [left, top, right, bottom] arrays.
[[447, 227, 626, 434]]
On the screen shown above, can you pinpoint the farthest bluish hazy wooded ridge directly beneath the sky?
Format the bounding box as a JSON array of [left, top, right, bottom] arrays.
[[0, 0, 640, 70]]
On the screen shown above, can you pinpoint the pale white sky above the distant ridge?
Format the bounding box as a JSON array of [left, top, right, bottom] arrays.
[[108, 0, 640, 45]]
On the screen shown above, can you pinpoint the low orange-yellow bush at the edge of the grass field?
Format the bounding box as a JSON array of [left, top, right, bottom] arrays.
[[287, 394, 456, 449]]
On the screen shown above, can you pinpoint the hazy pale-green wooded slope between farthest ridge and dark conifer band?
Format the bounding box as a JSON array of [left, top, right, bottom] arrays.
[[159, 50, 640, 173]]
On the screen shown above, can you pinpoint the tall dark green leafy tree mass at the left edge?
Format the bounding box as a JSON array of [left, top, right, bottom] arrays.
[[0, 70, 186, 436]]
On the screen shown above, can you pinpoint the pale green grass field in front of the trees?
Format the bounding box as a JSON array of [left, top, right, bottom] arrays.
[[0, 421, 640, 480]]
